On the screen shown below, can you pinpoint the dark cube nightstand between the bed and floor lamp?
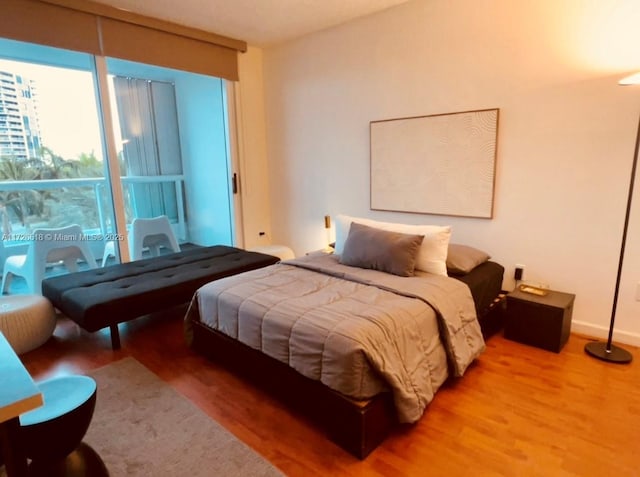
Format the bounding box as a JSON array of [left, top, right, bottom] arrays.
[[504, 290, 576, 353]]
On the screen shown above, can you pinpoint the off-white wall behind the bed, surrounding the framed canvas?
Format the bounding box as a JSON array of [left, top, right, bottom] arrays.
[[264, 0, 640, 344]]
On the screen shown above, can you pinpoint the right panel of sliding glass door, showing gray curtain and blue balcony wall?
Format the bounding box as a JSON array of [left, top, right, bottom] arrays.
[[107, 58, 234, 262]]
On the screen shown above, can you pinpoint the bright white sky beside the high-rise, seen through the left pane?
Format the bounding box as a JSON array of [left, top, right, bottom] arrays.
[[0, 59, 103, 160]]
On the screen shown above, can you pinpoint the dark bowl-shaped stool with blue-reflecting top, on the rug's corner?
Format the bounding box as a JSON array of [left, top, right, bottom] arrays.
[[20, 376, 109, 477]]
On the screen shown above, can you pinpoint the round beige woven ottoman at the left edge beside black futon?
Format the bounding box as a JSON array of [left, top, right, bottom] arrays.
[[0, 295, 56, 354]]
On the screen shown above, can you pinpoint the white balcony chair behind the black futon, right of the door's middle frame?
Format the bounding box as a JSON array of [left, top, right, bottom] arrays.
[[129, 215, 180, 260]]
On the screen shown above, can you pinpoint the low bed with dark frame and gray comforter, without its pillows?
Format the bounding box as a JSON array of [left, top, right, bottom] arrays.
[[185, 218, 504, 458]]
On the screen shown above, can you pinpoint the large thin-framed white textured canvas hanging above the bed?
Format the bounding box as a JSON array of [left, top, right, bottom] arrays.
[[370, 109, 499, 218]]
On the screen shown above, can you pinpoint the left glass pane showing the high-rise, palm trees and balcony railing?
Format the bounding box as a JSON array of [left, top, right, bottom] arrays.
[[0, 49, 113, 251]]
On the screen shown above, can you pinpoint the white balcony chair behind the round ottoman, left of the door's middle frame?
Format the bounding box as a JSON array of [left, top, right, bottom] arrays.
[[0, 225, 97, 295]]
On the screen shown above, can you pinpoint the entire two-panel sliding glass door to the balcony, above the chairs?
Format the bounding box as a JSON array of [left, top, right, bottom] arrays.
[[0, 35, 234, 288]]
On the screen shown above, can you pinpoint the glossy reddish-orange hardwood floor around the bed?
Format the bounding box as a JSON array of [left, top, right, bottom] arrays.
[[17, 310, 640, 477]]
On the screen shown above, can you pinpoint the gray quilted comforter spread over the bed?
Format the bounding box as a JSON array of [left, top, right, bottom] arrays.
[[186, 255, 484, 422]]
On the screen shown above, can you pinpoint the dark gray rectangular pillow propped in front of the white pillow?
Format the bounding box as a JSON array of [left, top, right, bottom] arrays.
[[340, 222, 424, 277]]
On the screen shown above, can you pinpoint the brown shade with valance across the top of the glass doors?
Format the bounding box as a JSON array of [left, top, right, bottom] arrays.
[[0, 0, 247, 81]]
